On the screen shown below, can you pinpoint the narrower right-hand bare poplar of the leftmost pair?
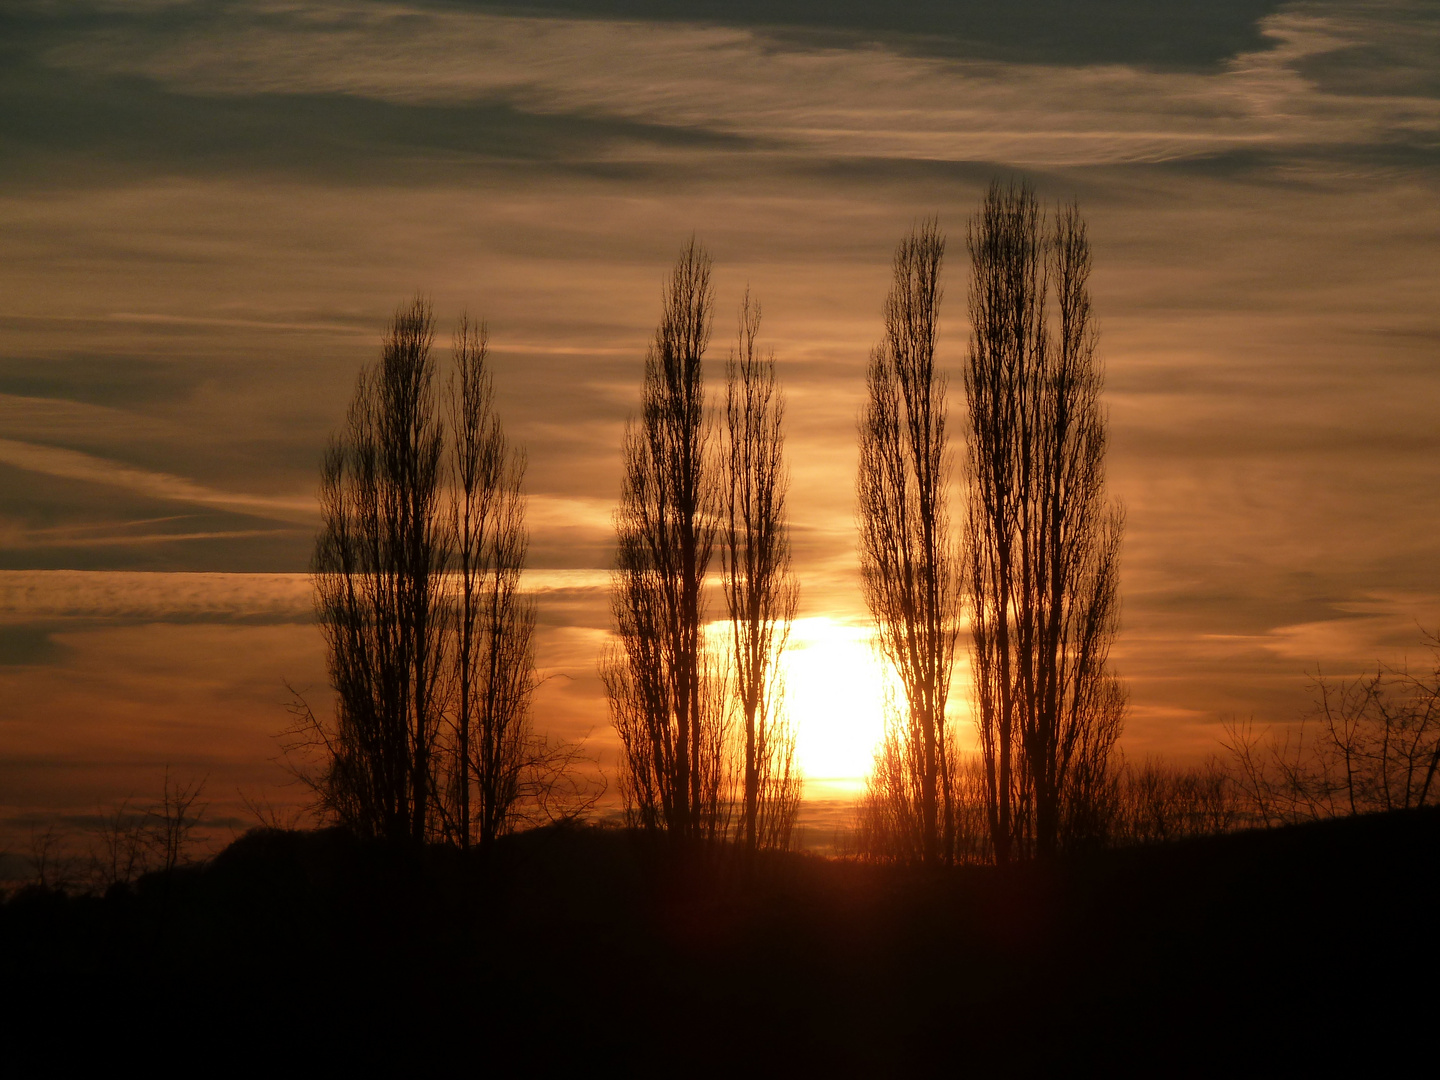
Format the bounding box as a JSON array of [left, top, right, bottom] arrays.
[[449, 318, 536, 848]]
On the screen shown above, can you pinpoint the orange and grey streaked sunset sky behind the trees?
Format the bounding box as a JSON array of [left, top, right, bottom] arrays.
[[0, 0, 1440, 822]]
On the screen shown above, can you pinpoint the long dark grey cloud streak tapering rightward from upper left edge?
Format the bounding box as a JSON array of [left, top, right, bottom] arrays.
[[0, 62, 755, 186]]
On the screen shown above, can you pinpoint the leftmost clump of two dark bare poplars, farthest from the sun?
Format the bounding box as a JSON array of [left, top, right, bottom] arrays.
[[288, 300, 603, 847]]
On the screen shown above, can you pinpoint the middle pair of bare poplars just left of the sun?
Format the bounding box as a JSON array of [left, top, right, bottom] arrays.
[[600, 249, 801, 851]]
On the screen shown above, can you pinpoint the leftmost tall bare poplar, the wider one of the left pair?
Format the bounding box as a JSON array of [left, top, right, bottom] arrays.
[[311, 298, 448, 844]]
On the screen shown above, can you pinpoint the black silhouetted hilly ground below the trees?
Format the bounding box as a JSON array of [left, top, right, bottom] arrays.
[[0, 811, 1440, 1076]]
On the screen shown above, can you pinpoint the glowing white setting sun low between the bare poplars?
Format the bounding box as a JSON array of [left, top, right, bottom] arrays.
[[780, 616, 884, 795]]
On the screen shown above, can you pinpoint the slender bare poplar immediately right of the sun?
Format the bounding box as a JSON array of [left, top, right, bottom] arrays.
[[857, 222, 960, 864]]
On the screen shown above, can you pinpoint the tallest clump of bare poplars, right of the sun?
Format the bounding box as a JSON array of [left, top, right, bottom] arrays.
[[858, 183, 1126, 864]]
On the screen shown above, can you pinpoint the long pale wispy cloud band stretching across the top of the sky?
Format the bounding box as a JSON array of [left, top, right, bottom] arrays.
[[25, 4, 1440, 173]]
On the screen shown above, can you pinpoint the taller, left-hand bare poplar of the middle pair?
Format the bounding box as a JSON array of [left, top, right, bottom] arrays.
[[600, 240, 724, 838]]
